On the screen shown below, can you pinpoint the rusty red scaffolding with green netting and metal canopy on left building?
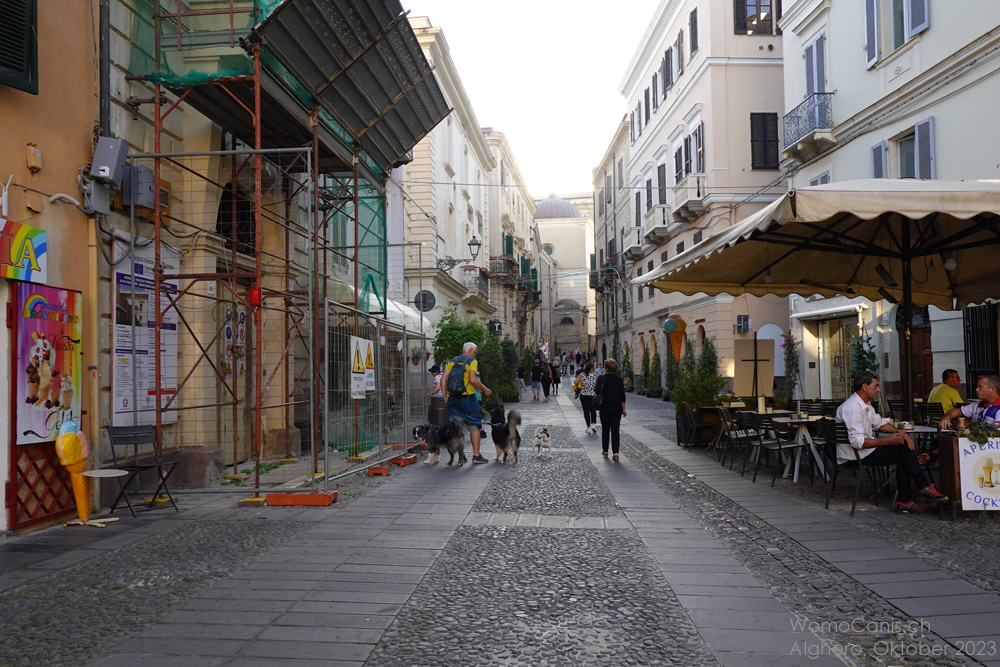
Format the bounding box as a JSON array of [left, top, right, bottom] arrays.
[[112, 0, 450, 491]]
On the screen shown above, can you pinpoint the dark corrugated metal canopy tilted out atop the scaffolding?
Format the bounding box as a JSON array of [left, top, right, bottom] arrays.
[[256, 0, 450, 174]]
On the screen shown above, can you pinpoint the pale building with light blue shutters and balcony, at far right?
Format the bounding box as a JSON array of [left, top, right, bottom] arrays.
[[780, 0, 1000, 398]]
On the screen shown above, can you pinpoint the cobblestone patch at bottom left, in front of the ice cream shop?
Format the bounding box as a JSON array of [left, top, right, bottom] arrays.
[[0, 521, 314, 665]]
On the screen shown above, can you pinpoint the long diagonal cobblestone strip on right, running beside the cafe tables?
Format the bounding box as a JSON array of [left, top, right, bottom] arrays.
[[622, 433, 976, 667]]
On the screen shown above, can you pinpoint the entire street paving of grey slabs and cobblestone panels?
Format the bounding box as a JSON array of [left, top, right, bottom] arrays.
[[0, 395, 1000, 667]]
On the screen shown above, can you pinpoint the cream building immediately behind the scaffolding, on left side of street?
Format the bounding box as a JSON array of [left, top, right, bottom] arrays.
[[401, 16, 496, 322]]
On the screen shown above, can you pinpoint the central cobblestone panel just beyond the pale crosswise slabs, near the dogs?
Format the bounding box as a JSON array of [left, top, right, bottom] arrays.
[[473, 452, 622, 517]]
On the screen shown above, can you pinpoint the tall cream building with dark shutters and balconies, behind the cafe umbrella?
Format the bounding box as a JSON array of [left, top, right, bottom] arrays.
[[619, 0, 788, 388]]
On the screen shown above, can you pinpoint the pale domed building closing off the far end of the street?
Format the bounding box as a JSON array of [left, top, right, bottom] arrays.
[[535, 194, 596, 354]]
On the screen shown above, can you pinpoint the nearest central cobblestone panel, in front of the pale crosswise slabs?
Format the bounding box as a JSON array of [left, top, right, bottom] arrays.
[[366, 526, 718, 667]]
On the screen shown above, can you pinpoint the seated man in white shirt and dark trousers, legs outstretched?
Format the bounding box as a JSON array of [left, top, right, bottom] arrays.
[[837, 371, 948, 514]]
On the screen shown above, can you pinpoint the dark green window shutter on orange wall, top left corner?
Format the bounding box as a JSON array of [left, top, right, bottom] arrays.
[[0, 0, 38, 95]]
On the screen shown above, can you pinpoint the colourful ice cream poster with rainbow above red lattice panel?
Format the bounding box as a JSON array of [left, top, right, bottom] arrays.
[[14, 283, 83, 445]]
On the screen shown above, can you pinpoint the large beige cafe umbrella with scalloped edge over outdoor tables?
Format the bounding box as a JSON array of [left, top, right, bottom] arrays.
[[633, 179, 1000, 415]]
